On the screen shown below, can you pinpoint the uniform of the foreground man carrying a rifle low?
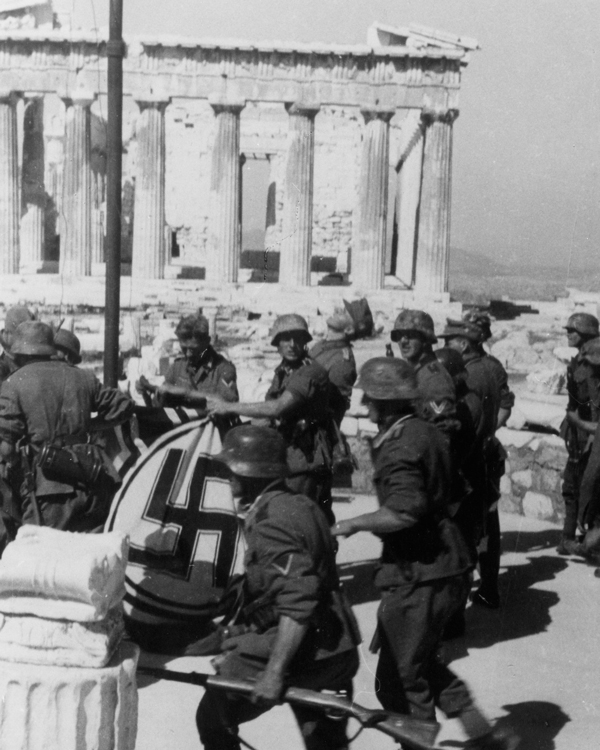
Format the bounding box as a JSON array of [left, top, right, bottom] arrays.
[[196, 483, 359, 750]]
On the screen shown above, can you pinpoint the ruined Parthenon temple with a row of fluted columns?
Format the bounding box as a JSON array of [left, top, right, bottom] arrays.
[[0, 19, 477, 295]]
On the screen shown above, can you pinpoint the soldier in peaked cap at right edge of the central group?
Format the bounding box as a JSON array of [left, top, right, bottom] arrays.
[[442, 319, 504, 609]]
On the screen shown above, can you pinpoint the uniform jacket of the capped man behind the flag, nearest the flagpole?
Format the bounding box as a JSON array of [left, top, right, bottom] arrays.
[[165, 346, 239, 406]]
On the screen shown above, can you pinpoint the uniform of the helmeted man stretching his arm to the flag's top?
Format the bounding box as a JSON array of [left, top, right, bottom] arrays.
[[265, 359, 332, 520]]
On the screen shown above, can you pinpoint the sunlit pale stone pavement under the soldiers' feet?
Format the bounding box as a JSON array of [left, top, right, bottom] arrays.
[[137, 496, 600, 750]]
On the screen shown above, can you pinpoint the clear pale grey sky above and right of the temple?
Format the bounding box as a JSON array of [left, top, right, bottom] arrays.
[[71, 0, 600, 272]]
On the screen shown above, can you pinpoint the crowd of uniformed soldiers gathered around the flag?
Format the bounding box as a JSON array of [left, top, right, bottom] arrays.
[[5, 308, 584, 750]]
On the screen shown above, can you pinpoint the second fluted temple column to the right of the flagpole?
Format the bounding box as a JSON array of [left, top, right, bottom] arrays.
[[206, 101, 245, 284]]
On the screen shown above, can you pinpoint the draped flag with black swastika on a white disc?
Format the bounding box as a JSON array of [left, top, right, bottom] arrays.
[[105, 419, 244, 651]]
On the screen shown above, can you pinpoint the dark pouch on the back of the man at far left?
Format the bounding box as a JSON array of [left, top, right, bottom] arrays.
[[37, 443, 105, 488]]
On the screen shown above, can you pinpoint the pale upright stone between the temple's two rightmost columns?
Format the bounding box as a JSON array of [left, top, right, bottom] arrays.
[[393, 110, 424, 286]]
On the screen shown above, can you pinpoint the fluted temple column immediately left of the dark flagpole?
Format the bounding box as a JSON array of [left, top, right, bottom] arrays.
[[59, 96, 93, 276]]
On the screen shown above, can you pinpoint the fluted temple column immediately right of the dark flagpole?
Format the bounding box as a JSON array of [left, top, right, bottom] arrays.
[[131, 101, 168, 279]]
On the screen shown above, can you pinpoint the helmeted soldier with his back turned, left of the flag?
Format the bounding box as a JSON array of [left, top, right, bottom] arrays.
[[0, 321, 133, 536]]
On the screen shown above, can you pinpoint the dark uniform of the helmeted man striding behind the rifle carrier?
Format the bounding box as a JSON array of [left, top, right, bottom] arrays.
[[372, 416, 472, 720]]
